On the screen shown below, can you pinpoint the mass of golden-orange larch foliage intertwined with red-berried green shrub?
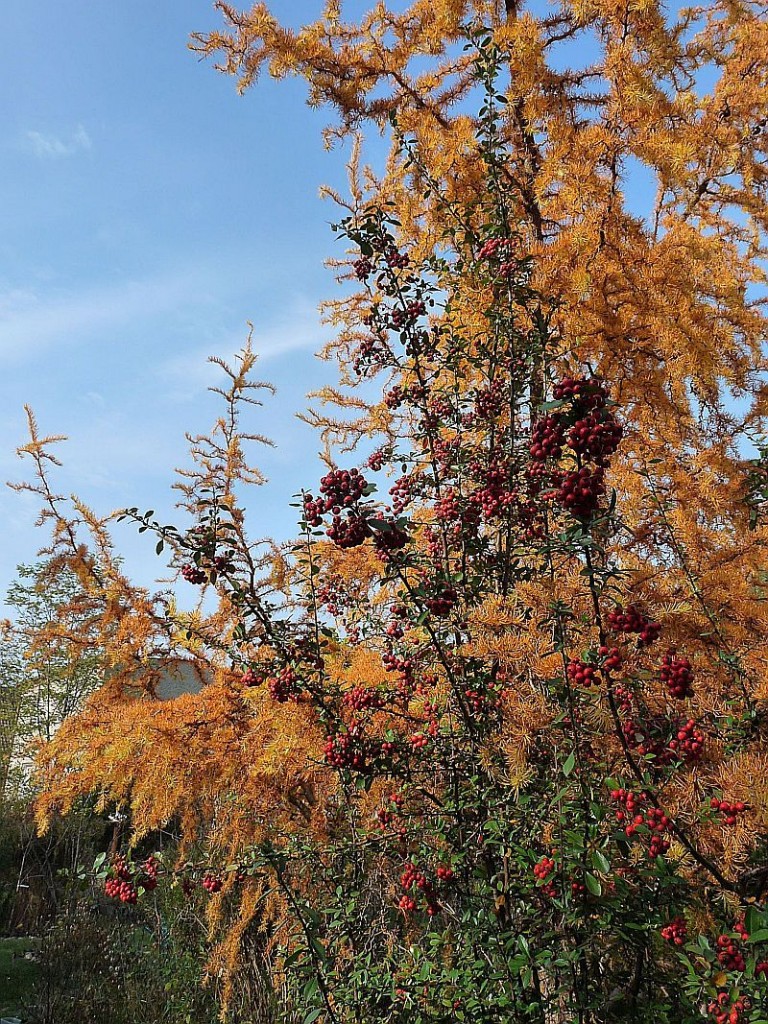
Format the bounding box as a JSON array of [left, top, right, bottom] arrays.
[[10, 0, 768, 1024]]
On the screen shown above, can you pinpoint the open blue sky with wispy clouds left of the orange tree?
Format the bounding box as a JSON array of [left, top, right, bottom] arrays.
[[0, 0, 385, 593]]
